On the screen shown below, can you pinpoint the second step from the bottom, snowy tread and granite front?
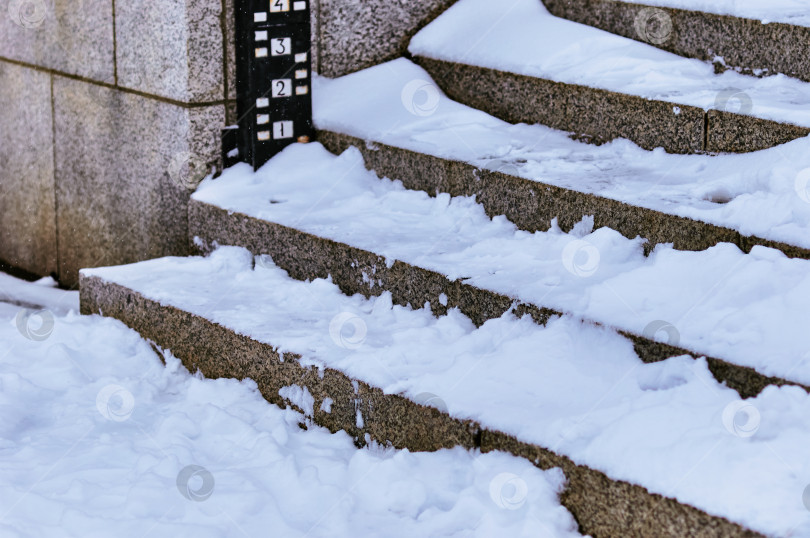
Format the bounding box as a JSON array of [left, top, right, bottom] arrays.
[[189, 143, 810, 395]]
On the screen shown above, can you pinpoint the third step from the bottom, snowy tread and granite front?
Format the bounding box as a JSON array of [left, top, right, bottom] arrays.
[[313, 59, 810, 258]]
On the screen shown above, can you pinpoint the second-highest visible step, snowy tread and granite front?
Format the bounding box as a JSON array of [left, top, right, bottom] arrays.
[[409, 0, 810, 153]]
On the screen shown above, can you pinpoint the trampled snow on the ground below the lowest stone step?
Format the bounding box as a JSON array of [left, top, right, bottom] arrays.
[[0, 273, 578, 538]]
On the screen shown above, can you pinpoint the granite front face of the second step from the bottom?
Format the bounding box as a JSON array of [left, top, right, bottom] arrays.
[[189, 200, 796, 397]]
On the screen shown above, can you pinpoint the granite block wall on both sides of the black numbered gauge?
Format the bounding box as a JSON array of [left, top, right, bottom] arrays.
[[0, 0, 454, 286]]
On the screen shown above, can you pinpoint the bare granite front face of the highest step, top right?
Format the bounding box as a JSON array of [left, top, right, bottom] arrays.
[[543, 0, 810, 81]]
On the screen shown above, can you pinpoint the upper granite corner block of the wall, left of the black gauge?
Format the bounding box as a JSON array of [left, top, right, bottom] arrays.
[[115, 0, 225, 103]]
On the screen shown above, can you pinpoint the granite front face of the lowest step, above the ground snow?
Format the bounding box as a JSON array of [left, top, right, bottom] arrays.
[[80, 276, 762, 536]]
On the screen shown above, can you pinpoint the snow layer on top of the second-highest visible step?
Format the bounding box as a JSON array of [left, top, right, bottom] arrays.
[[408, 0, 810, 126]]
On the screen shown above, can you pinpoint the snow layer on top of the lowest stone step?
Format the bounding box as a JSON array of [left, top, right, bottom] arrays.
[[85, 247, 810, 536]]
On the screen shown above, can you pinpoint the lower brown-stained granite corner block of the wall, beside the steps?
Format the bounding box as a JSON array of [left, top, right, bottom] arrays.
[[54, 76, 225, 286]]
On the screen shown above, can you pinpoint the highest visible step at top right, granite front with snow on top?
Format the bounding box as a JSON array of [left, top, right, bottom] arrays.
[[543, 0, 810, 81]]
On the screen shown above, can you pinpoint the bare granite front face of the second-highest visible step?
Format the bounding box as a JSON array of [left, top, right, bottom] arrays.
[[414, 57, 810, 154]]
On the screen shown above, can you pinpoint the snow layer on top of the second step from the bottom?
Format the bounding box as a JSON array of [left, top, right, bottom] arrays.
[[193, 144, 810, 385]]
